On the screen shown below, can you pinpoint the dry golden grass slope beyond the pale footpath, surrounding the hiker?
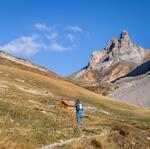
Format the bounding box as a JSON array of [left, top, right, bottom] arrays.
[[0, 64, 150, 149]]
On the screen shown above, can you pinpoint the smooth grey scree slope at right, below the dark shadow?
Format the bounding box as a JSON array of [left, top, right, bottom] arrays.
[[109, 74, 150, 107]]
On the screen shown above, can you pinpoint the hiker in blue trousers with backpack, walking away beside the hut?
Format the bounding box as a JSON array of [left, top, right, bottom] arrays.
[[75, 99, 83, 124]]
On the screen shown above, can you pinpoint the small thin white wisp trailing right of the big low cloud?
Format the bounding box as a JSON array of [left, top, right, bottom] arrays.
[[47, 43, 71, 51]]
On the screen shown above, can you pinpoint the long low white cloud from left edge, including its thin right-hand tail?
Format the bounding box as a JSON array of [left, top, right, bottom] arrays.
[[0, 35, 71, 57]]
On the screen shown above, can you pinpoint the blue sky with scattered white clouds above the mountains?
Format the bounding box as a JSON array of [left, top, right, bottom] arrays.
[[0, 0, 150, 76]]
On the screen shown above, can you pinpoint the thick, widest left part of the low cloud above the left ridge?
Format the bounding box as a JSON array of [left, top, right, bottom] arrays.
[[0, 35, 45, 56]]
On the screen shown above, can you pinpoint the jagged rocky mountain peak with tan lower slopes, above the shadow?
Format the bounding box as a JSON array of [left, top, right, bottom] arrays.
[[71, 31, 150, 84]]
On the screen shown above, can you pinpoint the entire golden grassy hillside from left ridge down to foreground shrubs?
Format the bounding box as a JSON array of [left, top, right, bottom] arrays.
[[0, 49, 150, 149]]
